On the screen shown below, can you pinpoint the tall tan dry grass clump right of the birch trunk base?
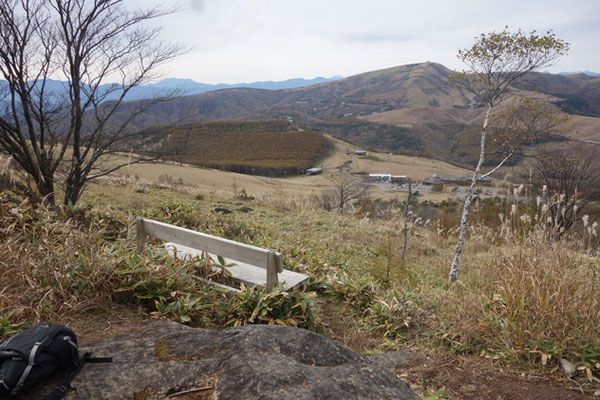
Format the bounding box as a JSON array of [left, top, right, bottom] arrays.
[[442, 234, 600, 361]]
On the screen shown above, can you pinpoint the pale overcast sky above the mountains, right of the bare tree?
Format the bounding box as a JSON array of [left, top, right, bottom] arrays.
[[126, 0, 600, 83]]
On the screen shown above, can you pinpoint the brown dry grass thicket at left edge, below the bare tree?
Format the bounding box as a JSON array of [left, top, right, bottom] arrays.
[[0, 194, 124, 321]]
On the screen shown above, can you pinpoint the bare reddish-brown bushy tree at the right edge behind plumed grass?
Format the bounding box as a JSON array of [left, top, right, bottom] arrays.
[[529, 143, 600, 233]]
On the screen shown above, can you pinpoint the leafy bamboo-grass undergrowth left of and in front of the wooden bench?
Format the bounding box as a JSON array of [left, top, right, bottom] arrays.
[[0, 193, 320, 337]]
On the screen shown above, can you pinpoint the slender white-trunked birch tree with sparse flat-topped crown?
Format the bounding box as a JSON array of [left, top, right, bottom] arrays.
[[449, 28, 569, 282]]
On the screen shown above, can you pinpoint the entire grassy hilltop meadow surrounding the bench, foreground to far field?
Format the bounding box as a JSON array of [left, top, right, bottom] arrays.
[[0, 141, 600, 399]]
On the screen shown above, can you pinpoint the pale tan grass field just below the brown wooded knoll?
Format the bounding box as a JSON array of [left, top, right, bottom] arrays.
[[91, 134, 470, 208]]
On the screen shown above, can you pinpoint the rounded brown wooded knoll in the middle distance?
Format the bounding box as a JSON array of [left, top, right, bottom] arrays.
[[138, 121, 333, 176]]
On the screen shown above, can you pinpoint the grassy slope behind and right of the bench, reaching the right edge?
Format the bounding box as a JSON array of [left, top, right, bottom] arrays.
[[45, 181, 600, 398]]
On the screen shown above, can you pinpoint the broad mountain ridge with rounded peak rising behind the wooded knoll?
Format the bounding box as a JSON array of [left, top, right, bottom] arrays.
[[109, 62, 600, 164]]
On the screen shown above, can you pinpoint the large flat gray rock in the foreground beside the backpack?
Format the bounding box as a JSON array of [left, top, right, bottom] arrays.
[[21, 321, 419, 400]]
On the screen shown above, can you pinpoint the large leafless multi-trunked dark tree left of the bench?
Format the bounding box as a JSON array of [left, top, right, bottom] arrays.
[[0, 0, 182, 204]]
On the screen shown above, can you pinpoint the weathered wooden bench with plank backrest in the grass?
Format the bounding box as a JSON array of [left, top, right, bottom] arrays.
[[136, 217, 308, 291]]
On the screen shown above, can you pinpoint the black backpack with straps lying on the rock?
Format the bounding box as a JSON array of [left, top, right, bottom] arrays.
[[0, 324, 111, 399]]
